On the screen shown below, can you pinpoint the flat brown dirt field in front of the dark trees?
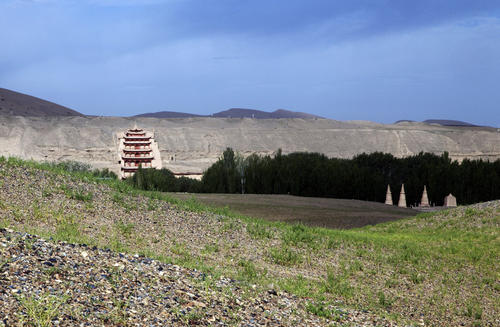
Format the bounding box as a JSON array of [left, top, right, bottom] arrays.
[[169, 193, 418, 229]]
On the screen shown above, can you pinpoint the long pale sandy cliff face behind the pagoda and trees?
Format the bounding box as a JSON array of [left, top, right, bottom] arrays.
[[0, 116, 500, 176]]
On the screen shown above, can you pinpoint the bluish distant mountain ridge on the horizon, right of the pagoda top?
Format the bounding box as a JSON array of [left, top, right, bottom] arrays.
[[133, 108, 323, 119]]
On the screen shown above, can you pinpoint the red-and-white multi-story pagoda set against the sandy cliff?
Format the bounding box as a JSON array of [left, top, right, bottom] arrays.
[[118, 126, 161, 179]]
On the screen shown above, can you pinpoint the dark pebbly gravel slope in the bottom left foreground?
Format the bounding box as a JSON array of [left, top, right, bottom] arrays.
[[0, 229, 324, 326]]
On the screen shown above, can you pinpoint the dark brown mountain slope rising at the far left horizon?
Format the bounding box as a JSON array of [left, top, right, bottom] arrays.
[[0, 88, 84, 117]]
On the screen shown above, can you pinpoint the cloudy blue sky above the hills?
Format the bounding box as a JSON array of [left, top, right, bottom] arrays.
[[0, 0, 500, 127]]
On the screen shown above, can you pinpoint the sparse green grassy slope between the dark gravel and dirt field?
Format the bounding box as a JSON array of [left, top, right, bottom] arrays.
[[0, 159, 500, 326]]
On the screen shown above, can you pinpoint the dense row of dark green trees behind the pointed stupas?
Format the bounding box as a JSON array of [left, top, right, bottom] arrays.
[[128, 148, 500, 205]]
